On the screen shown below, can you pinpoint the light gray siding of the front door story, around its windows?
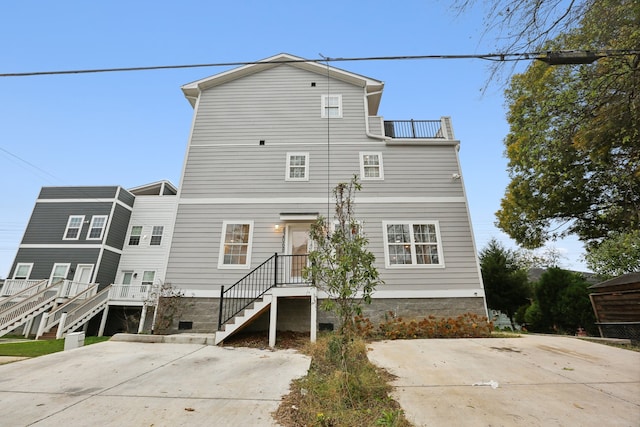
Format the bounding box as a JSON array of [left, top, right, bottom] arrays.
[[166, 201, 479, 290]]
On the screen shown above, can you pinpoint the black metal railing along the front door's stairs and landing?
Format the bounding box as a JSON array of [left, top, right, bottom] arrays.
[[218, 253, 309, 330]]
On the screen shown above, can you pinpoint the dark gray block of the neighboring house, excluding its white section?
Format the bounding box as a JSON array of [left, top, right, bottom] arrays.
[[7, 186, 134, 292]]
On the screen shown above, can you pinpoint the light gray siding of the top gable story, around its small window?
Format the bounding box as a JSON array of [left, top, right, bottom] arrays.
[[191, 65, 365, 150]]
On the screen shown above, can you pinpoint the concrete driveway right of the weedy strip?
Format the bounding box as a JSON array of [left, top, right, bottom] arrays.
[[369, 335, 640, 427]]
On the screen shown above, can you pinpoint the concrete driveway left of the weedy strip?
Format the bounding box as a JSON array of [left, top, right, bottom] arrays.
[[0, 341, 310, 427]]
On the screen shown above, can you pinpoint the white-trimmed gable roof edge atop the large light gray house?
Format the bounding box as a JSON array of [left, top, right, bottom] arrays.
[[182, 53, 384, 115]]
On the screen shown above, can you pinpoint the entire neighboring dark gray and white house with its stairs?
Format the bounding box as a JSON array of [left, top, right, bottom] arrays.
[[0, 181, 177, 338]]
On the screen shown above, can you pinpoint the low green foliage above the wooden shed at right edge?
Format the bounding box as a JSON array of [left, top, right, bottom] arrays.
[[585, 230, 640, 277]]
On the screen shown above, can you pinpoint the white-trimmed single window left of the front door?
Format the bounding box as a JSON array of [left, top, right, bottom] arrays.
[[218, 221, 253, 268]]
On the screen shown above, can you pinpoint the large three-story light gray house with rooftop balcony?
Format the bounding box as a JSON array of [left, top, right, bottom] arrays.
[[166, 54, 487, 340]]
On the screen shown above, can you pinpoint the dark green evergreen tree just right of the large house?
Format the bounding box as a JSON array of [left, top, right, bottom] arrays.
[[480, 239, 531, 328]]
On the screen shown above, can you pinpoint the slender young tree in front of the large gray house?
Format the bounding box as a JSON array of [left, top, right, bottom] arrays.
[[304, 176, 384, 336]]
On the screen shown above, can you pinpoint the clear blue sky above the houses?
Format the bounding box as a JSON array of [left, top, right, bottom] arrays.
[[0, 0, 584, 277]]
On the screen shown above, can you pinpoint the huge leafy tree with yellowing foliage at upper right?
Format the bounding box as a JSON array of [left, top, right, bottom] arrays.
[[496, 0, 640, 248]]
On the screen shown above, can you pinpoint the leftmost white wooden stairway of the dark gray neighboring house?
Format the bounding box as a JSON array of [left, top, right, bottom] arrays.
[[0, 280, 61, 337]]
